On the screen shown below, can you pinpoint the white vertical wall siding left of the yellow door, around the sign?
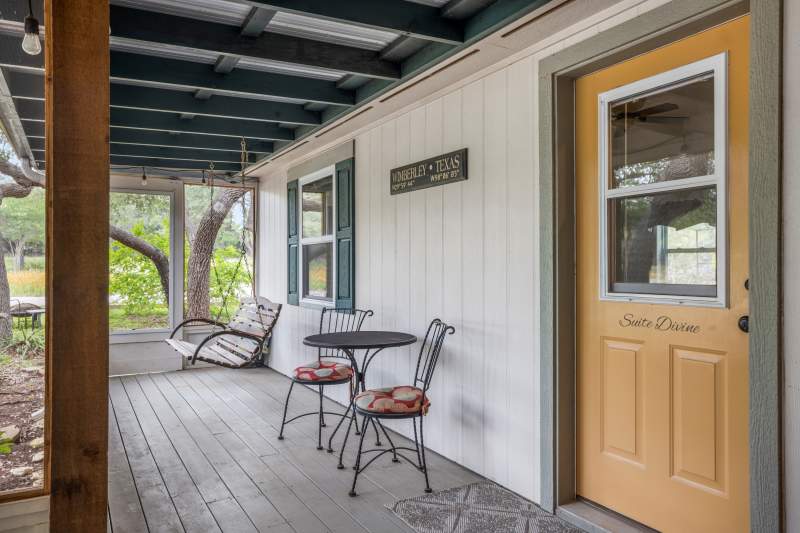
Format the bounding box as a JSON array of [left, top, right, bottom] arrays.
[[261, 58, 539, 499]]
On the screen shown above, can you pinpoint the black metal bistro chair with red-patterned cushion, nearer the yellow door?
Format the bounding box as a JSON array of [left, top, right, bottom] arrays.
[[350, 318, 456, 496]]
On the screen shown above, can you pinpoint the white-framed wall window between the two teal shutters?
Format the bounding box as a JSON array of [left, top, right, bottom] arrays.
[[299, 168, 335, 304]]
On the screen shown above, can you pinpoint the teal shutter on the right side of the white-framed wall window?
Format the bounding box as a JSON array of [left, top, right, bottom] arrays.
[[336, 158, 356, 309]]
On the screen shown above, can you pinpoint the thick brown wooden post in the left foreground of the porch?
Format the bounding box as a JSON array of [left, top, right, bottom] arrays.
[[44, 0, 109, 533]]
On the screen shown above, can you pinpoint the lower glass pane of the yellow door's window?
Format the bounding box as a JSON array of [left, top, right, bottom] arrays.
[[610, 187, 717, 296]]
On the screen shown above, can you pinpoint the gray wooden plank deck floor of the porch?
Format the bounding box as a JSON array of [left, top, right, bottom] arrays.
[[109, 368, 480, 533]]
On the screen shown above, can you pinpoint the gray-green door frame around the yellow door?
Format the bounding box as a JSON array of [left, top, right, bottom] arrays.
[[538, 0, 783, 531]]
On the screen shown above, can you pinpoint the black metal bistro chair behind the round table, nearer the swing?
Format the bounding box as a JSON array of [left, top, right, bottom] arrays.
[[278, 307, 373, 450]]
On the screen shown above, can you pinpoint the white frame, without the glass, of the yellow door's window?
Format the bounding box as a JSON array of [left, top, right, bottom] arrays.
[[598, 53, 728, 307]]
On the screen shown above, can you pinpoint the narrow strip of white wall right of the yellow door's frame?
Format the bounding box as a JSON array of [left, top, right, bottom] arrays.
[[783, 0, 800, 531]]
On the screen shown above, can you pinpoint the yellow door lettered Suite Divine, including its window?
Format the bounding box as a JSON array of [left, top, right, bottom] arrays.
[[575, 17, 749, 533]]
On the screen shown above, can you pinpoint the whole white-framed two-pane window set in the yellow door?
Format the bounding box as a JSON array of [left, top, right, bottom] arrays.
[[599, 55, 726, 305]]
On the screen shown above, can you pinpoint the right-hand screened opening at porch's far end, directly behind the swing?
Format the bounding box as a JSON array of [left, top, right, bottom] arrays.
[[183, 184, 255, 322]]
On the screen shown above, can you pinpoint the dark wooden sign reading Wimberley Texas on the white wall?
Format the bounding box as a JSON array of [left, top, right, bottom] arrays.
[[389, 148, 467, 194]]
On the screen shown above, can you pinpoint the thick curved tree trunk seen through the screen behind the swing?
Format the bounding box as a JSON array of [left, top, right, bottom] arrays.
[[186, 188, 247, 318]]
